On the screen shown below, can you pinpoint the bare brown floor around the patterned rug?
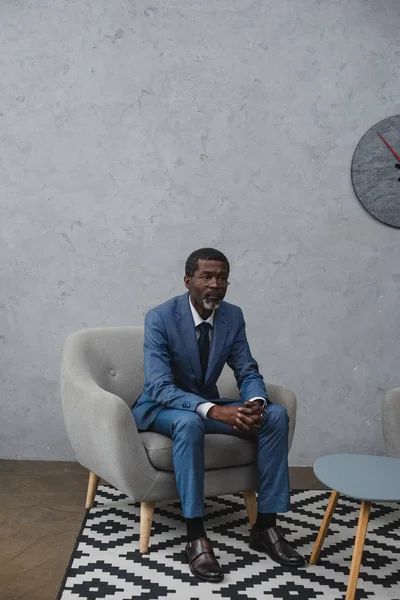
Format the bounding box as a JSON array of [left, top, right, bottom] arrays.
[[0, 460, 323, 600]]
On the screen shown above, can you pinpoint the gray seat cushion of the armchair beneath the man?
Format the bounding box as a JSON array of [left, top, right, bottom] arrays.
[[139, 431, 257, 471]]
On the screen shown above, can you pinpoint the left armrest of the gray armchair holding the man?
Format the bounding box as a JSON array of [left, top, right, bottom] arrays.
[[61, 336, 157, 501]]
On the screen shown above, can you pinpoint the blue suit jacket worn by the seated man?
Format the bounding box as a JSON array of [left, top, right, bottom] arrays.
[[132, 293, 267, 430]]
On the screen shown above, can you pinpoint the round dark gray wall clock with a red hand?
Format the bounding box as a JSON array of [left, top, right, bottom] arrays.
[[351, 115, 400, 227]]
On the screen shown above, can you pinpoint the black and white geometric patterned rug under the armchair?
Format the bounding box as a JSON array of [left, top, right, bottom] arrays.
[[58, 486, 400, 600]]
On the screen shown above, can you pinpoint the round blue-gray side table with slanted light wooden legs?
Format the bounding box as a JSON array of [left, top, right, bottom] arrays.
[[309, 454, 400, 600]]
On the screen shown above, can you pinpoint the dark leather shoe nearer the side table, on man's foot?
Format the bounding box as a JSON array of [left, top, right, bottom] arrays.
[[249, 527, 306, 567]]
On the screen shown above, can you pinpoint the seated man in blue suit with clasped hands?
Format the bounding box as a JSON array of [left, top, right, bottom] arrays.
[[132, 248, 305, 581]]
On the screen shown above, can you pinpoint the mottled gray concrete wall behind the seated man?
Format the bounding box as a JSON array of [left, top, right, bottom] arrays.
[[0, 0, 400, 465]]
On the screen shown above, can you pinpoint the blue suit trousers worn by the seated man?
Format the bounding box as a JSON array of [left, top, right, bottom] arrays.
[[149, 401, 290, 519]]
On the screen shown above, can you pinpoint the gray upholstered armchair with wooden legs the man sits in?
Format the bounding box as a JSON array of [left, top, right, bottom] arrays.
[[61, 327, 296, 552]]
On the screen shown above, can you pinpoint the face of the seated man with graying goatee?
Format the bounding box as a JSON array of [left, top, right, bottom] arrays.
[[184, 260, 229, 311]]
